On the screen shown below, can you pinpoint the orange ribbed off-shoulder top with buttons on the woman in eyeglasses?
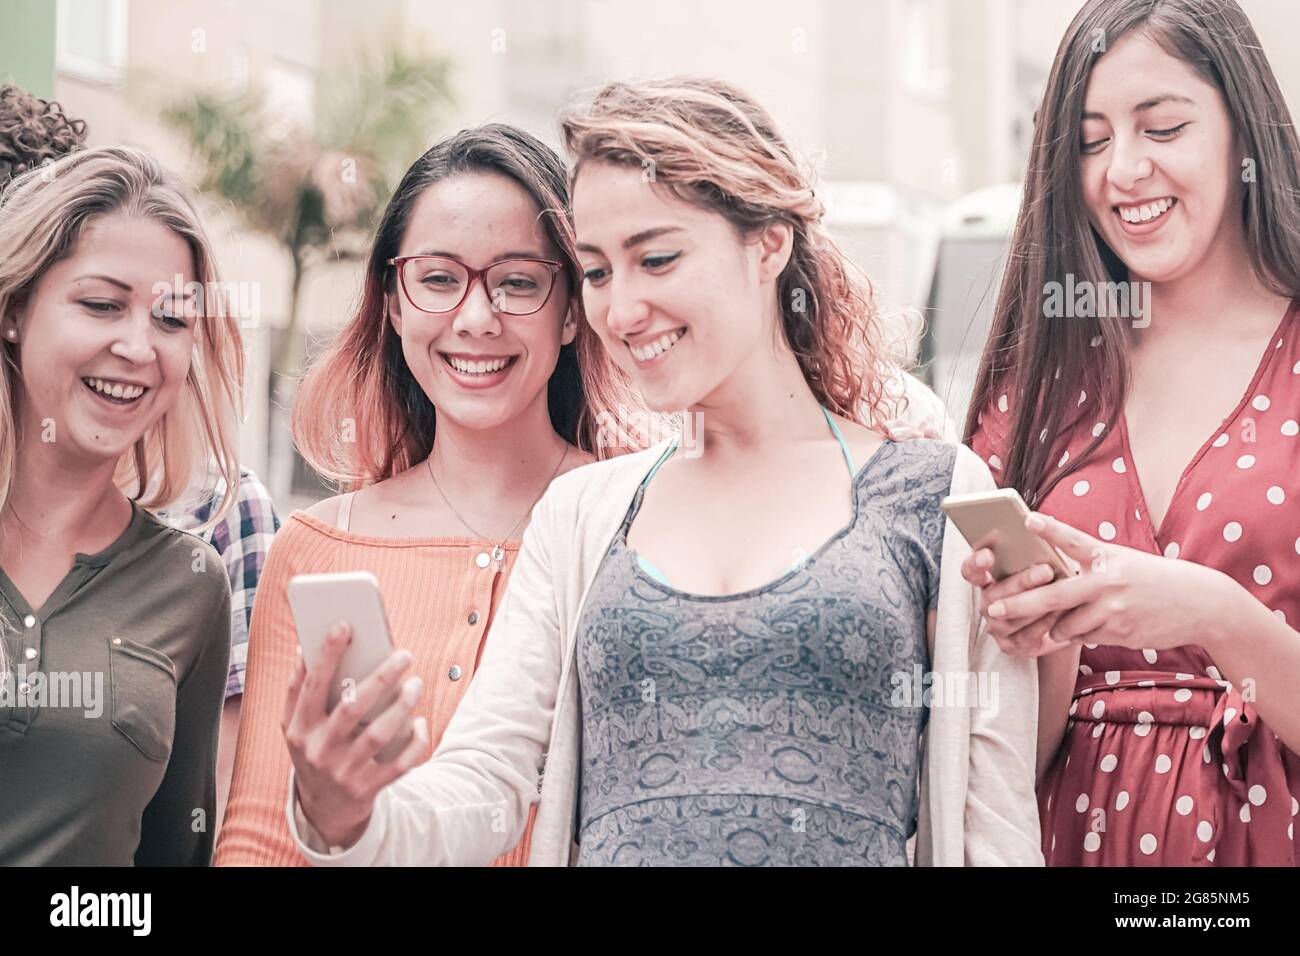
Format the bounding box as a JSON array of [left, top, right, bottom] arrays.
[[215, 511, 537, 866]]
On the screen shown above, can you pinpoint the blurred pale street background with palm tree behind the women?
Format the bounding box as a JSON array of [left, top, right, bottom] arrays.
[[0, 0, 1300, 514]]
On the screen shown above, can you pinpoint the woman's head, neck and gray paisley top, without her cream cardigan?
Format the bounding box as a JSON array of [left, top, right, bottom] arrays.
[[564, 81, 982, 865]]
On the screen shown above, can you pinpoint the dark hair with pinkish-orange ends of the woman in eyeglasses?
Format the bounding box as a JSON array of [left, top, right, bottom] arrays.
[[293, 124, 642, 488]]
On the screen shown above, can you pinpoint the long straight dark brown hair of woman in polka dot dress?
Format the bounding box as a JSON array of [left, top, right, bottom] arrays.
[[965, 0, 1300, 506]]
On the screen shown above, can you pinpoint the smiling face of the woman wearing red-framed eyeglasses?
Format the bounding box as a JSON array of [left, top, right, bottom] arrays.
[[387, 173, 577, 429]]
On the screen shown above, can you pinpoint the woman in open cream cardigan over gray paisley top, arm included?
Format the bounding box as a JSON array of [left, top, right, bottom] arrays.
[[285, 78, 1043, 866]]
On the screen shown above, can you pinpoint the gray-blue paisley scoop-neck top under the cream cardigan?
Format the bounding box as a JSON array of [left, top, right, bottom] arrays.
[[577, 440, 957, 866]]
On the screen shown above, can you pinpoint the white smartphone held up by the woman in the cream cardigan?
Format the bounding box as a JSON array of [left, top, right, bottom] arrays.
[[287, 571, 413, 763]]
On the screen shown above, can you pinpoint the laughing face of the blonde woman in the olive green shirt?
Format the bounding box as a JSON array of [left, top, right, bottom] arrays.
[[4, 212, 198, 464]]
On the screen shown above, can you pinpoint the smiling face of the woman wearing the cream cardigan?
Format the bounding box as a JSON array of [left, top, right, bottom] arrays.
[[573, 161, 774, 411]]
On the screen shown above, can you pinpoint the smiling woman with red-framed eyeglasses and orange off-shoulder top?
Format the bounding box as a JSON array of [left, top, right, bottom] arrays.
[[216, 125, 640, 865]]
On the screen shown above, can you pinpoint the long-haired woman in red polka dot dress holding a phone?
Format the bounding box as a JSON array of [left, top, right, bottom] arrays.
[[965, 0, 1300, 866]]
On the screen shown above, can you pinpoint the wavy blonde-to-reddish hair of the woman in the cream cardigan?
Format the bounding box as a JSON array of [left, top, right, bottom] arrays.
[[562, 77, 889, 425]]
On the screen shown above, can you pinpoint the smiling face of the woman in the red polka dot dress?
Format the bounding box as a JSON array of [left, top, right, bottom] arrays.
[[1080, 33, 1243, 282]]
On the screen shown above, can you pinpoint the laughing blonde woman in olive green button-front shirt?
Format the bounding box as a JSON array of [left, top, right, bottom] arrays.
[[0, 148, 243, 866]]
